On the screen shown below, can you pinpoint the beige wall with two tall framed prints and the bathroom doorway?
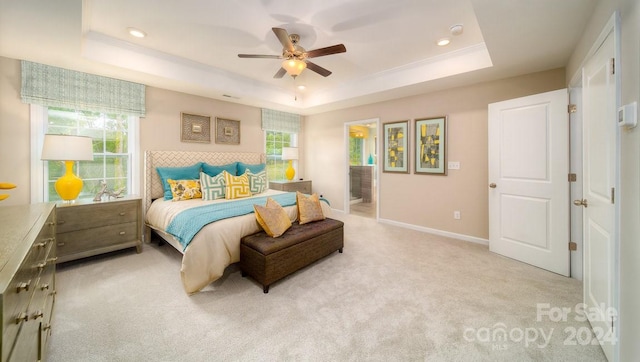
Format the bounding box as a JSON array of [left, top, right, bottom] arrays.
[[305, 69, 565, 239]]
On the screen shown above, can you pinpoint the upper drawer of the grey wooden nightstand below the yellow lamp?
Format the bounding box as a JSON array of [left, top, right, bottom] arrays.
[[58, 200, 139, 234]]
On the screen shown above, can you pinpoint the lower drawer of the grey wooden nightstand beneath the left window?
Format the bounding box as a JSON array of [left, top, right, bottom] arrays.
[[57, 220, 139, 259]]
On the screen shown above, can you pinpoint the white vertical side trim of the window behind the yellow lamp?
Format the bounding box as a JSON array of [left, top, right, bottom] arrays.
[[29, 104, 141, 203]]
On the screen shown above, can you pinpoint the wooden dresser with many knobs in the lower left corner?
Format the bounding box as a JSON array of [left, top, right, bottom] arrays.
[[0, 204, 56, 362]]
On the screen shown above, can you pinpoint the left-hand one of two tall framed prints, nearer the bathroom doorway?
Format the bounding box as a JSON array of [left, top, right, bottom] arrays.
[[382, 121, 409, 173]]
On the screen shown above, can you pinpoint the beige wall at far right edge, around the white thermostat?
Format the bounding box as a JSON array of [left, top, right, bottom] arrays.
[[567, 0, 640, 361]]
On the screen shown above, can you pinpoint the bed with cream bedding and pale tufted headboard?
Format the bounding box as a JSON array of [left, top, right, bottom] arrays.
[[144, 151, 331, 294]]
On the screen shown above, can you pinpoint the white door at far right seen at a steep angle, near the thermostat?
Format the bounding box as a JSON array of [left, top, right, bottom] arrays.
[[574, 27, 617, 361]]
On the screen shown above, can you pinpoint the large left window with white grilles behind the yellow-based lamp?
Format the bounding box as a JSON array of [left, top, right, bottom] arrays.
[[32, 105, 139, 201]]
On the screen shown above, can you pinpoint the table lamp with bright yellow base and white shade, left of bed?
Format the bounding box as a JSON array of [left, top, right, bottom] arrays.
[[41, 134, 93, 202]]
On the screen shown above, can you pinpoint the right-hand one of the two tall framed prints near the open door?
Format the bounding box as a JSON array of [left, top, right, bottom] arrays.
[[414, 117, 447, 175]]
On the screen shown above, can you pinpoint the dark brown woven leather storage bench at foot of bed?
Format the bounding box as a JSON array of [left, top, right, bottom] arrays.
[[240, 218, 344, 293]]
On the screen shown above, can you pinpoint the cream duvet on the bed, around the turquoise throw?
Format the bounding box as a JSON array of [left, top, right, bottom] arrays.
[[145, 190, 331, 294]]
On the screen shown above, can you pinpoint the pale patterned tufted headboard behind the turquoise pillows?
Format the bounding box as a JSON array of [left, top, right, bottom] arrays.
[[144, 151, 266, 212]]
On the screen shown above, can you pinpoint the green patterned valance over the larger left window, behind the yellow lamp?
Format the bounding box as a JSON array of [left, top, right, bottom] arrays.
[[21, 60, 146, 117]]
